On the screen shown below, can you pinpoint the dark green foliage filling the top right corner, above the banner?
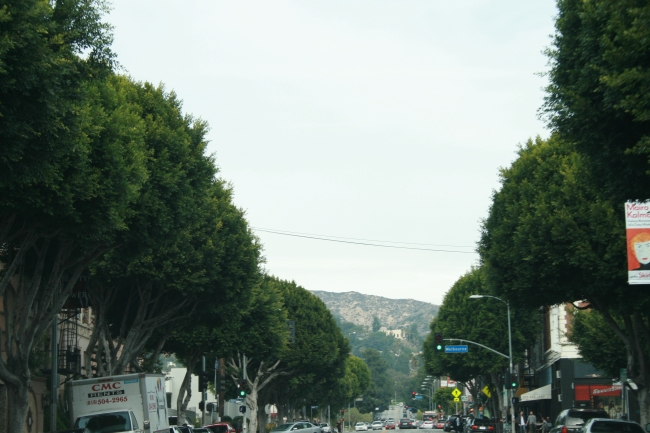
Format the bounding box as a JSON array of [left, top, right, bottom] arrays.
[[543, 0, 650, 205]]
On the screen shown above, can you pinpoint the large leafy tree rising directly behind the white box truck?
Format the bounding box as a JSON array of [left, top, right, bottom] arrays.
[[86, 77, 259, 375]]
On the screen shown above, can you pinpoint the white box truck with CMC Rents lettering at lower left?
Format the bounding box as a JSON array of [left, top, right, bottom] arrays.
[[72, 373, 169, 433]]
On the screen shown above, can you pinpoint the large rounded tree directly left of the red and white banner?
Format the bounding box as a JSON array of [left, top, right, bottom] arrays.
[[480, 136, 650, 423]]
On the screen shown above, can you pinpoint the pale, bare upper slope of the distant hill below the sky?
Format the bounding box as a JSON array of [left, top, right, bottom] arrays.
[[312, 290, 439, 335]]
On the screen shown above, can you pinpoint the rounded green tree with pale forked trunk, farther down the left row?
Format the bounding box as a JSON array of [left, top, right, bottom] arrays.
[[229, 276, 350, 433]]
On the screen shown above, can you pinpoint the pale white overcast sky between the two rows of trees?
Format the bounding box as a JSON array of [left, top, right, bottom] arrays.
[[107, 0, 556, 304]]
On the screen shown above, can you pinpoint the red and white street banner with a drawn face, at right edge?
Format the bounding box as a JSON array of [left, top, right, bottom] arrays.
[[625, 202, 650, 284]]
